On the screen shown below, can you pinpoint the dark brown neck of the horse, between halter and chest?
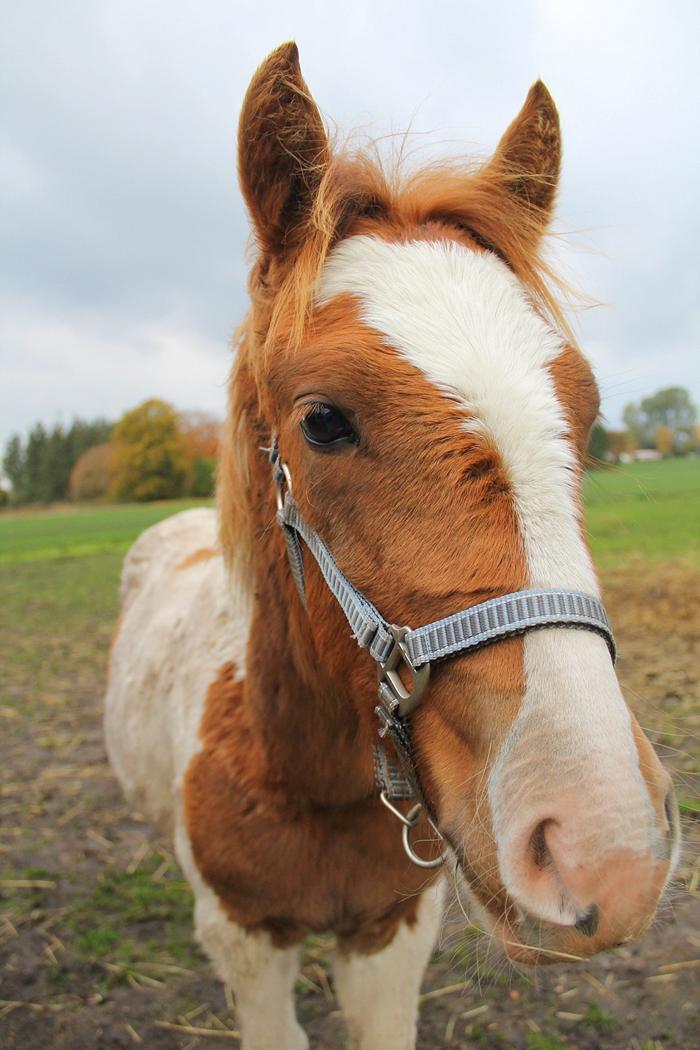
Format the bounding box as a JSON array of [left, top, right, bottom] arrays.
[[246, 480, 376, 805]]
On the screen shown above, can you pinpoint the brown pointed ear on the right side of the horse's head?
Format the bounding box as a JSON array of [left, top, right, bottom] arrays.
[[485, 80, 561, 233]]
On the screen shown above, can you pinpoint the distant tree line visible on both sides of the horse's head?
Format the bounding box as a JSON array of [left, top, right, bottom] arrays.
[[0, 386, 700, 505]]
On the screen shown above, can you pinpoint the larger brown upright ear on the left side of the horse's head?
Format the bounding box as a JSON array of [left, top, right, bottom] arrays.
[[238, 42, 330, 257]]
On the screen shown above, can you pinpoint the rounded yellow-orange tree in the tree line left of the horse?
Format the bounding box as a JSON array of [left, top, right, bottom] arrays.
[[110, 398, 189, 502]]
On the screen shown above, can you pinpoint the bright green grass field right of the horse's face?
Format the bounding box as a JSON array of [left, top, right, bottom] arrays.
[[584, 459, 700, 566]]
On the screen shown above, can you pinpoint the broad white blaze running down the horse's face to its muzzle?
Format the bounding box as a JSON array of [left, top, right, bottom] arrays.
[[318, 236, 654, 921]]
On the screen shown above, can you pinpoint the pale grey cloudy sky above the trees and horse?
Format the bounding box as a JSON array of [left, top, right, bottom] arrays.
[[0, 0, 700, 443]]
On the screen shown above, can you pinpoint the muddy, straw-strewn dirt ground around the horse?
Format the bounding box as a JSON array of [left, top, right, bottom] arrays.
[[0, 563, 700, 1050]]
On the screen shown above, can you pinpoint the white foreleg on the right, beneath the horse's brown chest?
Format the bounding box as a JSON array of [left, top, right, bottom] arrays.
[[334, 883, 443, 1050]]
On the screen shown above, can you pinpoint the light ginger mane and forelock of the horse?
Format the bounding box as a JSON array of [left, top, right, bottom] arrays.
[[217, 143, 575, 585]]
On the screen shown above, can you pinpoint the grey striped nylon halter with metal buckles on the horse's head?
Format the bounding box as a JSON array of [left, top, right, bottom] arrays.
[[264, 439, 616, 867]]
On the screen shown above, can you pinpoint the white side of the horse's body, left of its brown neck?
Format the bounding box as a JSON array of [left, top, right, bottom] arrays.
[[105, 508, 250, 834]]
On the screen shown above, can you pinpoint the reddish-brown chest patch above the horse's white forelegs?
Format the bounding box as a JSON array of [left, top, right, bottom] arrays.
[[185, 730, 431, 950]]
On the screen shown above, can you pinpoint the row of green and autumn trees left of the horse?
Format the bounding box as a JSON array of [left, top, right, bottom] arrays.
[[0, 399, 221, 505]]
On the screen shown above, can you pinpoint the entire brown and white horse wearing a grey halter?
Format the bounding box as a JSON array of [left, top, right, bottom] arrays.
[[106, 43, 679, 1050]]
